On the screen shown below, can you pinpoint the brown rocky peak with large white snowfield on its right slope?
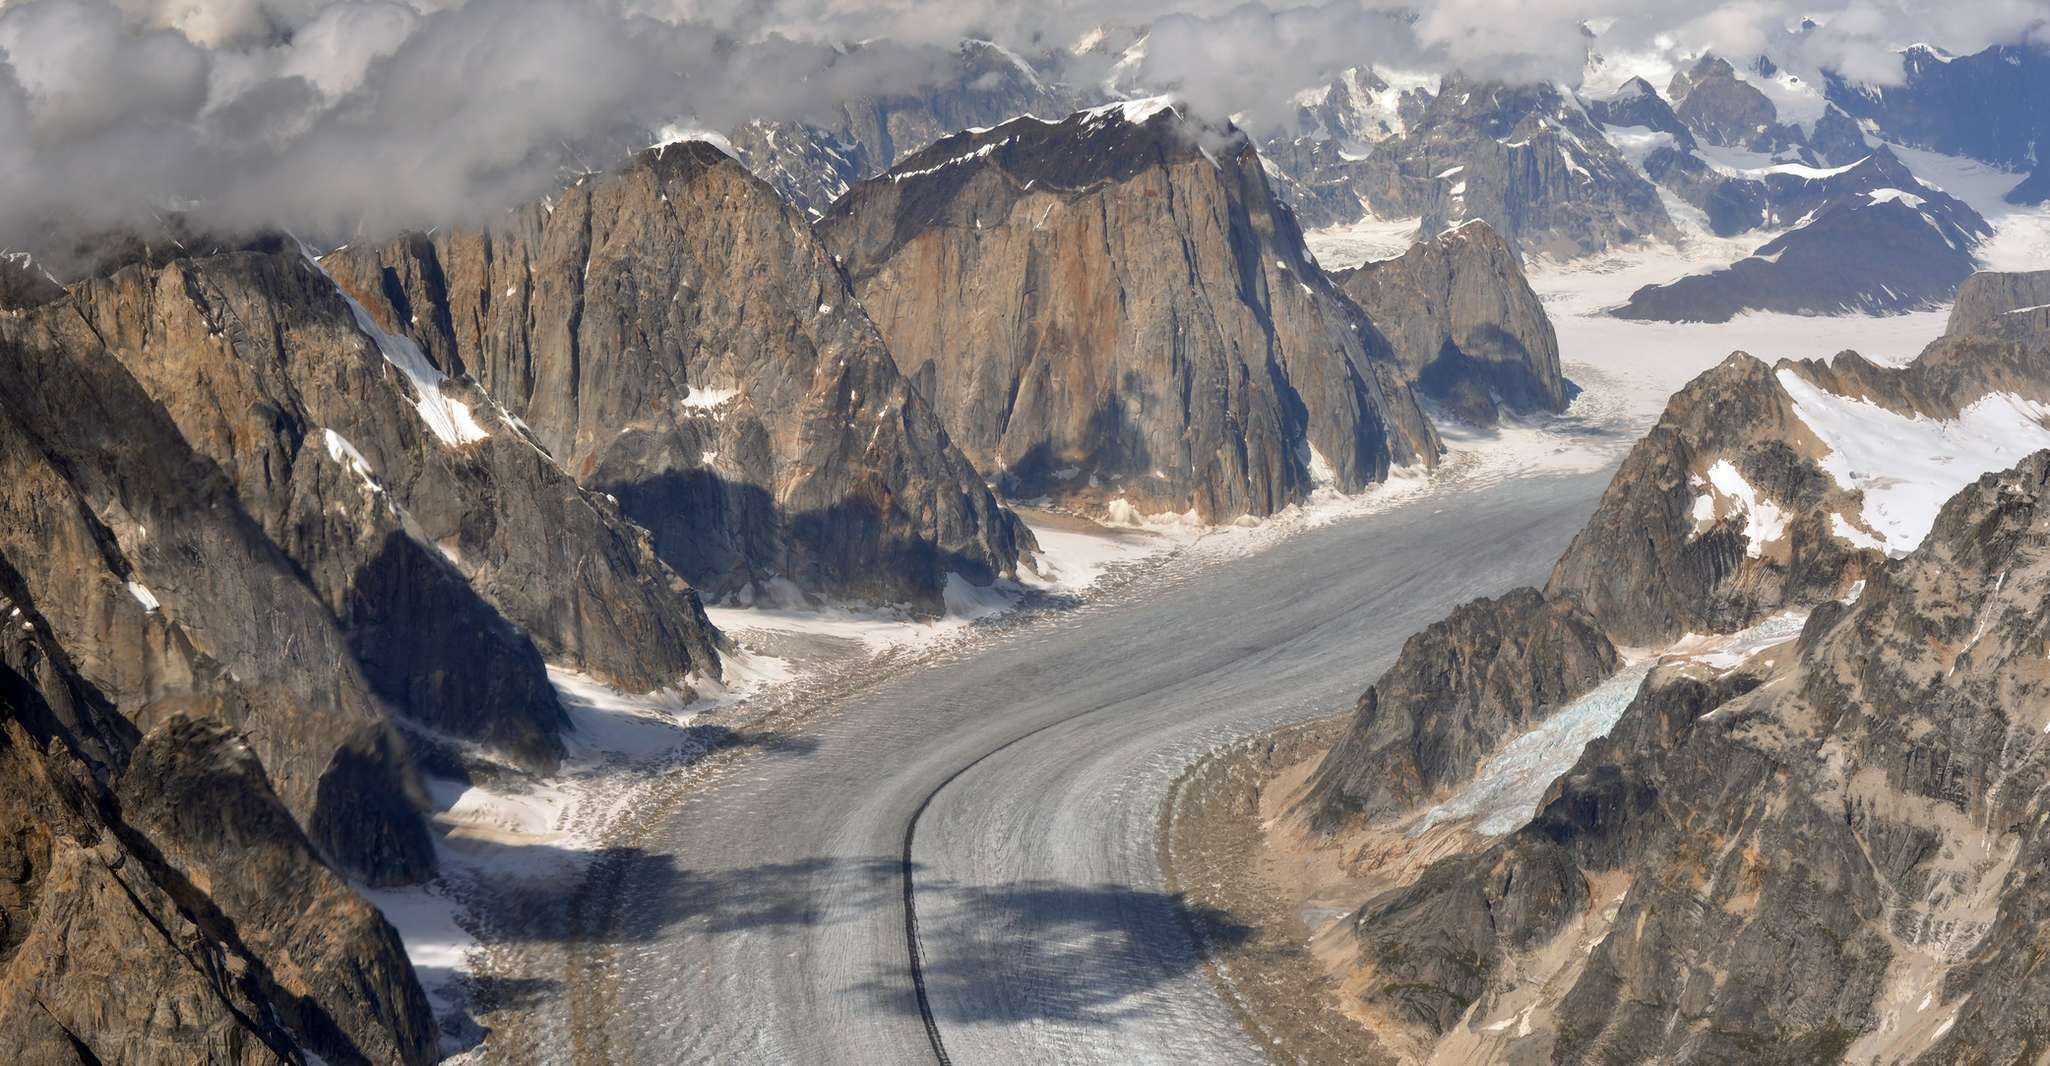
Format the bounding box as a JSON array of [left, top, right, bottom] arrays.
[[1548, 319, 2050, 646]]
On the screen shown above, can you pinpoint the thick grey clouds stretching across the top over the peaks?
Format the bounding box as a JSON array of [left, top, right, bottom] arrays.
[[0, 0, 2050, 262]]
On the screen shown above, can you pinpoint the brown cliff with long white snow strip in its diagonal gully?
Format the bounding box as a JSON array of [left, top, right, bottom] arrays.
[[78, 248, 718, 717]]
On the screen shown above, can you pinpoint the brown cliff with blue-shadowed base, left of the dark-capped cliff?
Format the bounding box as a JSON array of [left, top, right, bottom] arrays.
[[324, 141, 1029, 609]]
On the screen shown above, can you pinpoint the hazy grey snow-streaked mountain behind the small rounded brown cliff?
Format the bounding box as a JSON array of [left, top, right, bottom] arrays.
[[1363, 76, 1675, 256]]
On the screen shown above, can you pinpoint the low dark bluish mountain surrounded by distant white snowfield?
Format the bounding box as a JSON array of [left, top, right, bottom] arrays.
[[1613, 148, 1993, 322]]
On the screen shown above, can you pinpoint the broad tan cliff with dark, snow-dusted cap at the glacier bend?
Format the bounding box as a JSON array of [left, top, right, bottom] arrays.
[[820, 100, 1437, 519]]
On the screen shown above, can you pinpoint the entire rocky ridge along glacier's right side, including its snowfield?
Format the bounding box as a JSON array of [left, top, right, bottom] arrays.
[[1296, 264, 2050, 1062]]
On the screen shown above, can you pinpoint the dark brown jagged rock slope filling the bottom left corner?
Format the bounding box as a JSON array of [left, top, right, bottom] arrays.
[[0, 590, 439, 1066]]
